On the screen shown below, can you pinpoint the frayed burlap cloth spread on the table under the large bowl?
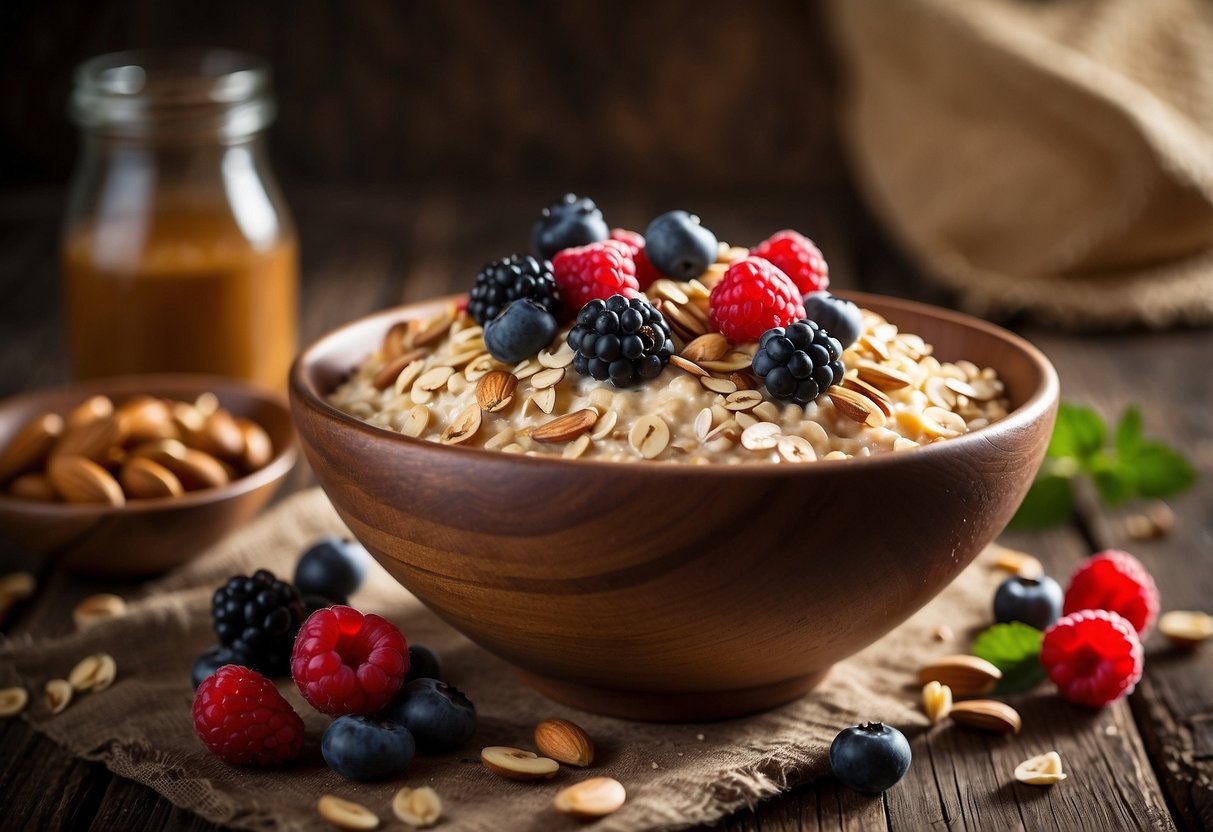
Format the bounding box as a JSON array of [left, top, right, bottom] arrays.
[[0, 490, 998, 832]]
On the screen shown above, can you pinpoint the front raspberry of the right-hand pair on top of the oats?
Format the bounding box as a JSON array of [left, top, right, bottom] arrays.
[[708, 257, 804, 341]]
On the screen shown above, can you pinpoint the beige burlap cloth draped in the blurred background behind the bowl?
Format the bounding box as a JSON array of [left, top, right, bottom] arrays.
[[828, 0, 1213, 326]]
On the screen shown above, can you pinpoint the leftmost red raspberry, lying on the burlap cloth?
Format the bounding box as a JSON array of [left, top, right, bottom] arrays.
[[194, 665, 303, 765]]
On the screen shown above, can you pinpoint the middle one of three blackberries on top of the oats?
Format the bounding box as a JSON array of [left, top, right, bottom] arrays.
[[569, 295, 674, 387]]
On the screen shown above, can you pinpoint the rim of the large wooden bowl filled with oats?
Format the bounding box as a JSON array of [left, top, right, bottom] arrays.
[[289, 291, 1060, 479]]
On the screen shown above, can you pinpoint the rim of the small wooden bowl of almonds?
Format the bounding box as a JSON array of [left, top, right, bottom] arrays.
[[0, 372, 298, 519]]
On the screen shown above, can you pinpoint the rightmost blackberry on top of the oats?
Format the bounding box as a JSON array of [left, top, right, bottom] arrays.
[[753, 320, 845, 405]]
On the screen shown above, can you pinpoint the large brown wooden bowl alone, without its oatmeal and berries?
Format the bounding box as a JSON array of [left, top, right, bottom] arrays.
[[290, 295, 1058, 720]]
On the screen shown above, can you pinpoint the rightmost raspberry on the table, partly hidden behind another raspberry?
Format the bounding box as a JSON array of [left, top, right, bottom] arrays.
[[1061, 549, 1158, 636]]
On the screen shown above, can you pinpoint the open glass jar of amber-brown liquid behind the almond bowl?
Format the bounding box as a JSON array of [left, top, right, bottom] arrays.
[[62, 50, 298, 388]]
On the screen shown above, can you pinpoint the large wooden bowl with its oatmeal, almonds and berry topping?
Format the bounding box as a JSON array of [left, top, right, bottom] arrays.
[[291, 195, 1058, 720]]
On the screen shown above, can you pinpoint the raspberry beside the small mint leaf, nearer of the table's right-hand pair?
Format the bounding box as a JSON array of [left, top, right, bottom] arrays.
[[1041, 610, 1144, 708]]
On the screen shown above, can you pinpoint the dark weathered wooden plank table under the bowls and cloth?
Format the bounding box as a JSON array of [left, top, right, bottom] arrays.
[[0, 187, 1213, 830]]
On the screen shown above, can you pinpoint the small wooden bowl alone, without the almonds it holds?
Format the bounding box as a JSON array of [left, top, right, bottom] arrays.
[[0, 375, 298, 577]]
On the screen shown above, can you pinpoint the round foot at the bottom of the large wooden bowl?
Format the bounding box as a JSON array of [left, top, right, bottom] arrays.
[[517, 667, 830, 722]]
